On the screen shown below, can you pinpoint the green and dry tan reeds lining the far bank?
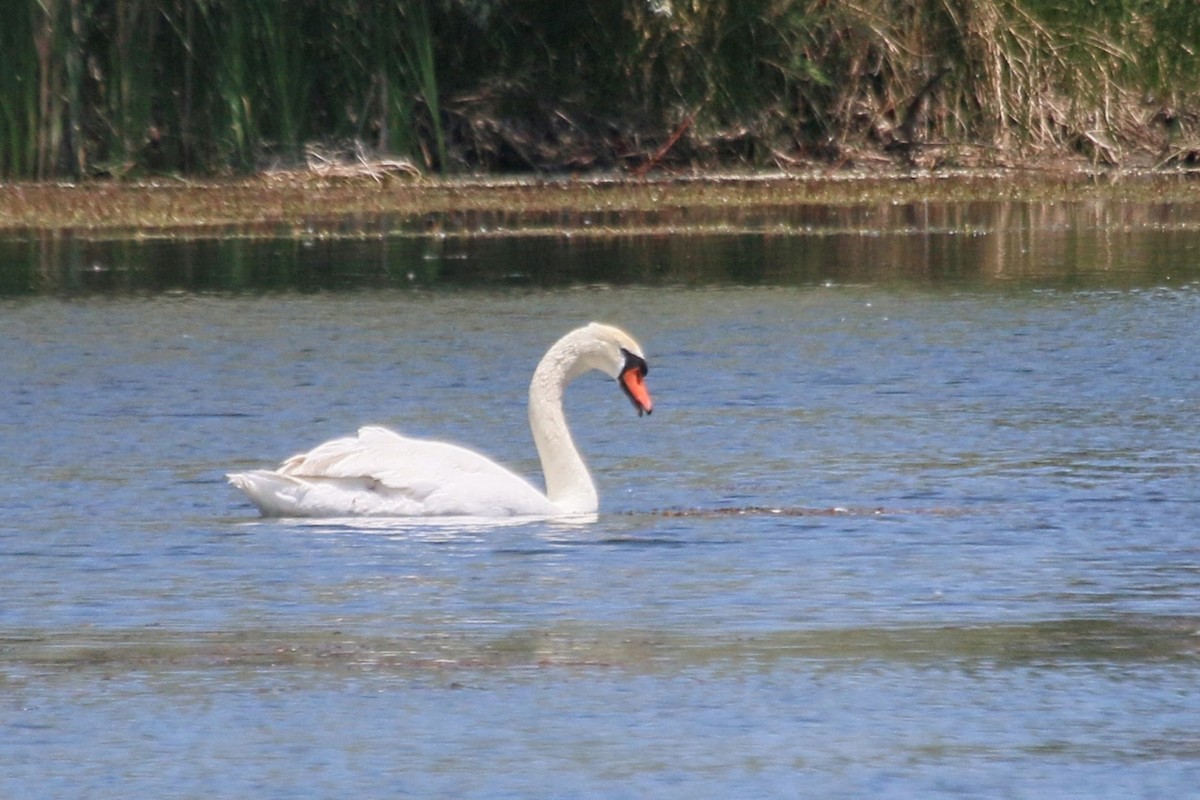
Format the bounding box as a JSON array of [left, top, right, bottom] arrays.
[[0, 0, 1200, 180]]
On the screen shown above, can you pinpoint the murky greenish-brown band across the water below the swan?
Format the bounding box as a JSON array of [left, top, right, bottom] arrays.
[[0, 615, 1200, 685]]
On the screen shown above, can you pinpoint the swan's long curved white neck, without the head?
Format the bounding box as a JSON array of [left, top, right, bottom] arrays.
[[529, 336, 599, 513]]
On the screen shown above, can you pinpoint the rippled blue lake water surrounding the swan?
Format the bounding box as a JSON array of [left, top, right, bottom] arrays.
[[0, 205, 1200, 800]]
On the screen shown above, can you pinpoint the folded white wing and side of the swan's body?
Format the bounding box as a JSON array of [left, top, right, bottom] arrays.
[[267, 427, 556, 517]]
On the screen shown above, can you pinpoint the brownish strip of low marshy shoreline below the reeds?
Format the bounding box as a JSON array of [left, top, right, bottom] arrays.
[[0, 163, 1200, 240]]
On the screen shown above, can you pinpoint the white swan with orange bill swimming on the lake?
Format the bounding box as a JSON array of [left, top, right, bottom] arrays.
[[226, 323, 654, 518]]
